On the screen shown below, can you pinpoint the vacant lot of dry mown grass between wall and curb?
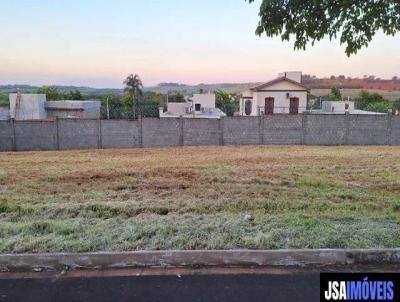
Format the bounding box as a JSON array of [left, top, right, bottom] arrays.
[[0, 147, 400, 253]]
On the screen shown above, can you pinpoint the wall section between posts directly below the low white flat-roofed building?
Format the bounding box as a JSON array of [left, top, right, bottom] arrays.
[[183, 119, 222, 146]]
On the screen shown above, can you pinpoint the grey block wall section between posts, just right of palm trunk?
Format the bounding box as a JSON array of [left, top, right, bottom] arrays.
[[141, 118, 182, 148]]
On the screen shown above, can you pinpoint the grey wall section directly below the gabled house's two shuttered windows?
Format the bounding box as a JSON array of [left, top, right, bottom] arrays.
[[262, 115, 303, 145]]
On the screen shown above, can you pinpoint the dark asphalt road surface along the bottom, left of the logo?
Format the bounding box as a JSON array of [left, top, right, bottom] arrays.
[[0, 272, 319, 302]]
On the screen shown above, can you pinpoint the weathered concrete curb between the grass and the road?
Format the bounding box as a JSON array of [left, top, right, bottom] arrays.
[[0, 249, 400, 272]]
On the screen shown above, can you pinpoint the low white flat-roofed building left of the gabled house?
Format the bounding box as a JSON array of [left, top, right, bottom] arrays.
[[160, 93, 226, 119]]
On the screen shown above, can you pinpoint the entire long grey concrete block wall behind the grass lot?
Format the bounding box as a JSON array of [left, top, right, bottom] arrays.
[[0, 115, 400, 151]]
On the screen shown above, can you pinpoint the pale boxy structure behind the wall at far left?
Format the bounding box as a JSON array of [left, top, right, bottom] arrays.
[[9, 93, 47, 120]]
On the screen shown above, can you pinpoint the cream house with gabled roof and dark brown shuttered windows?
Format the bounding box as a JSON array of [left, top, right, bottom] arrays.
[[240, 71, 308, 116]]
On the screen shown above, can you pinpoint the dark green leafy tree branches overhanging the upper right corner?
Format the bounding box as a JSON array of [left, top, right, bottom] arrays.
[[249, 0, 400, 56]]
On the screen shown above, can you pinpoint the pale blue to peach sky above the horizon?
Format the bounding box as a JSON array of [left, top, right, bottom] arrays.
[[0, 0, 400, 87]]
